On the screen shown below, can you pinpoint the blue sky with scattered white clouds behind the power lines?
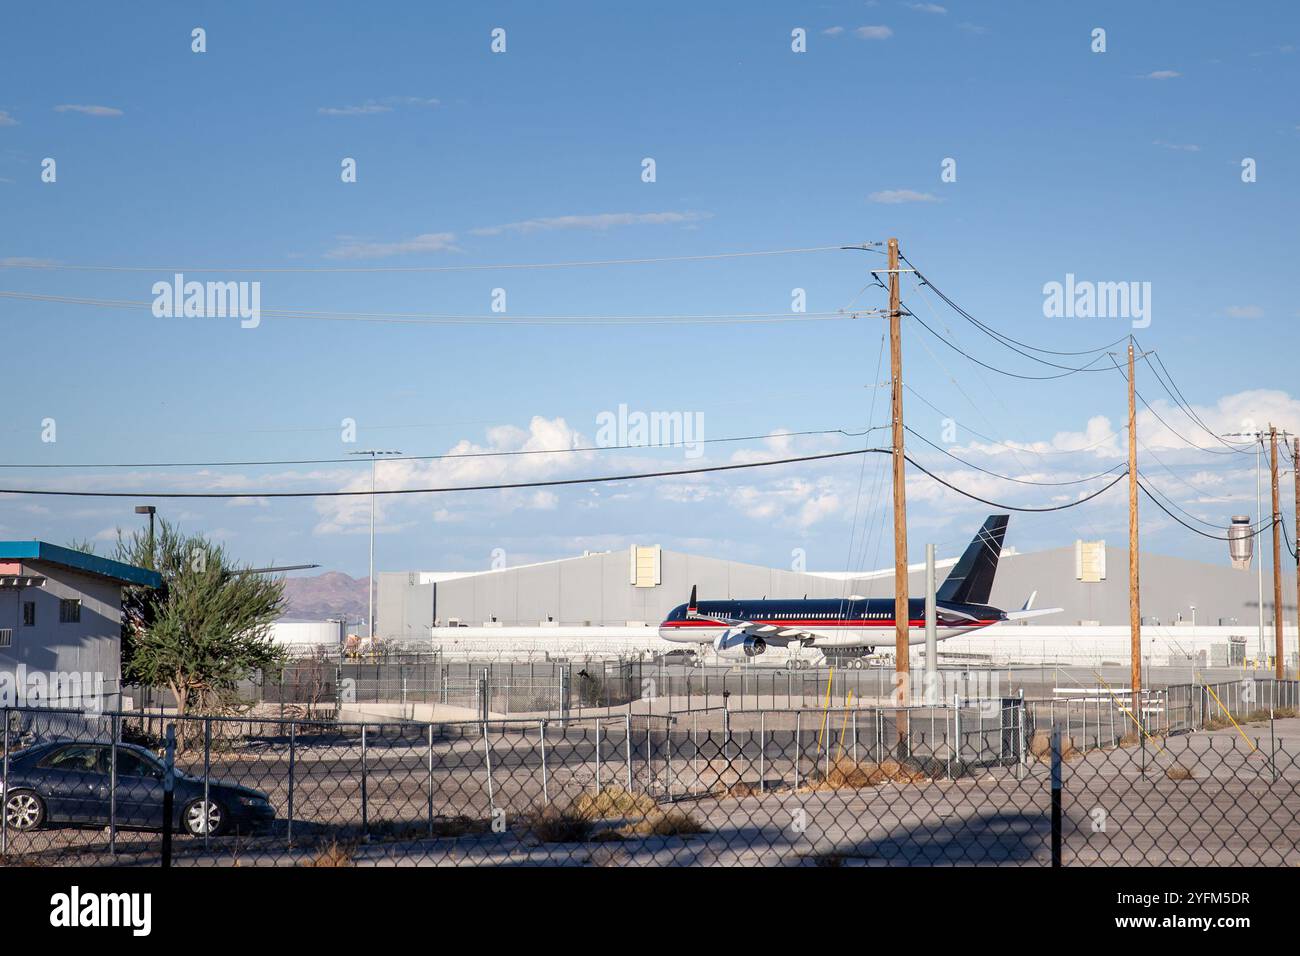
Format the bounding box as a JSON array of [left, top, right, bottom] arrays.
[[0, 0, 1300, 587]]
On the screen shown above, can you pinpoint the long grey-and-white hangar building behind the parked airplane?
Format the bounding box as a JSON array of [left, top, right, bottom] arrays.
[[376, 541, 1296, 666]]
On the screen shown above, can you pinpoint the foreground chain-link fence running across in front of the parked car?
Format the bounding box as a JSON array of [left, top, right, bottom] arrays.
[[0, 695, 1300, 866]]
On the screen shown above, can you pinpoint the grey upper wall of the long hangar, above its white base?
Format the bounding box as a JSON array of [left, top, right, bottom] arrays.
[[377, 546, 1279, 641]]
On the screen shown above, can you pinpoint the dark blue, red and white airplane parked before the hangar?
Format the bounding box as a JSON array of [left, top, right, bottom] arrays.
[[659, 515, 1063, 658]]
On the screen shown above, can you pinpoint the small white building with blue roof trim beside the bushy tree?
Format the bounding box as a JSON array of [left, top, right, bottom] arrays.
[[0, 541, 163, 709]]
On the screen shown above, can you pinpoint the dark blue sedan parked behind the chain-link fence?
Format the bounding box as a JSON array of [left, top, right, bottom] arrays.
[[3, 741, 276, 836]]
